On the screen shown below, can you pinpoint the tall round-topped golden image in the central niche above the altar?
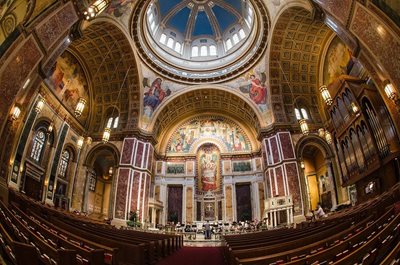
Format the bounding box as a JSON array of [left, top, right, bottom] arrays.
[[197, 144, 220, 192]]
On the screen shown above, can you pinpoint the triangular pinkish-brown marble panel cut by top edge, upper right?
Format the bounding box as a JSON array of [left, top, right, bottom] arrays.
[[314, 0, 353, 25]]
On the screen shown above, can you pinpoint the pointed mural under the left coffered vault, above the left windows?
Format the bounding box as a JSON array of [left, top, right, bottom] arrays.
[[45, 51, 89, 120]]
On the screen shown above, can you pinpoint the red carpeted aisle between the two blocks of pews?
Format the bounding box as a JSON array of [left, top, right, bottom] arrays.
[[157, 247, 225, 265]]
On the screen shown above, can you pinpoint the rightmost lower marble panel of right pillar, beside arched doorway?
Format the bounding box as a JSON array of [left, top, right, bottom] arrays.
[[285, 162, 303, 215]]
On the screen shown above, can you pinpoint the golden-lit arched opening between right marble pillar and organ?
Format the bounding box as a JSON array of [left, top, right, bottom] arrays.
[[296, 135, 338, 210]]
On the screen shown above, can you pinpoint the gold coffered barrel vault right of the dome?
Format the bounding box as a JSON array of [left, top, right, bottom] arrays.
[[270, 8, 331, 123]]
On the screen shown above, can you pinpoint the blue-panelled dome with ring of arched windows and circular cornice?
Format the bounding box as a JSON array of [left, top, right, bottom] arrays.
[[132, 0, 268, 83]]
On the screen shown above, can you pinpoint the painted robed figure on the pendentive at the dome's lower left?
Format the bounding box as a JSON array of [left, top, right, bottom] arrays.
[[143, 77, 171, 117]]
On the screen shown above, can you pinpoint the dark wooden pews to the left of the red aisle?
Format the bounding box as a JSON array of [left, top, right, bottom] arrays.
[[0, 190, 183, 265]]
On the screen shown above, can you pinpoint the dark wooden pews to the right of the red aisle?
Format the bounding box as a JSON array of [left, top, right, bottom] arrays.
[[224, 184, 400, 265]]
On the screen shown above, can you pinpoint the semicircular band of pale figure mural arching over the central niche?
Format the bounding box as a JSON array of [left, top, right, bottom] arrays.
[[166, 117, 251, 154]]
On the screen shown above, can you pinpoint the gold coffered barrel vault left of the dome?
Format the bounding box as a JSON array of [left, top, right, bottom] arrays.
[[71, 22, 140, 132]]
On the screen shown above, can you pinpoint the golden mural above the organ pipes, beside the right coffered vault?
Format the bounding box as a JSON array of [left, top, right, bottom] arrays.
[[323, 37, 354, 85]]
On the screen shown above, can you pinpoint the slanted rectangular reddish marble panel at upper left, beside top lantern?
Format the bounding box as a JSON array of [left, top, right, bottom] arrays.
[[36, 2, 79, 50]]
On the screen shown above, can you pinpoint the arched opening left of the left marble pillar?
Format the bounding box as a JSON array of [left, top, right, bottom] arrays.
[[83, 144, 119, 219]]
